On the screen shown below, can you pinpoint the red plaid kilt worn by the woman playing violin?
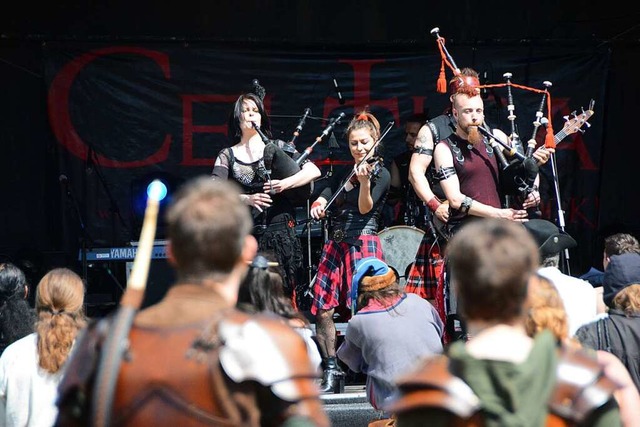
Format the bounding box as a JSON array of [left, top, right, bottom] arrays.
[[311, 235, 384, 321]]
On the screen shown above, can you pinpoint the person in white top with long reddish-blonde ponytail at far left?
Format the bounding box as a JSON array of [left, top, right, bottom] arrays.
[[0, 268, 86, 427]]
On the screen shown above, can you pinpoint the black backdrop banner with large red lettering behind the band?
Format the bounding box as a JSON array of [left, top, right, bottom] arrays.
[[44, 43, 609, 270]]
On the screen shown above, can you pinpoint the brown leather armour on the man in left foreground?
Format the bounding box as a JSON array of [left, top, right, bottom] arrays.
[[56, 310, 327, 427]]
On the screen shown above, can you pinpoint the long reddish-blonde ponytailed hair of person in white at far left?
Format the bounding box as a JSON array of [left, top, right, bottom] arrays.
[[36, 268, 86, 373]]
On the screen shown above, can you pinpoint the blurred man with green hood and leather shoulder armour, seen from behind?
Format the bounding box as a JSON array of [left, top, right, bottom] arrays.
[[388, 218, 621, 427]]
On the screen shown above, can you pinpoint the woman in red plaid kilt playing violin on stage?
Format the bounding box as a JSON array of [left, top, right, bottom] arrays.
[[310, 111, 391, 392]]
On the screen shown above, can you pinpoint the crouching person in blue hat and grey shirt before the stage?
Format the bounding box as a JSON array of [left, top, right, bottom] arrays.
[[337, 257, 444, 417]]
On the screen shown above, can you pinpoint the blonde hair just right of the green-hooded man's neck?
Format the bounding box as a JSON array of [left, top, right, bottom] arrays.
[[525, 273, 569, 341]]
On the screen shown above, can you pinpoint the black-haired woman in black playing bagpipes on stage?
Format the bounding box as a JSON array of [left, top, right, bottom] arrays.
[[212, 93, 321, 307]]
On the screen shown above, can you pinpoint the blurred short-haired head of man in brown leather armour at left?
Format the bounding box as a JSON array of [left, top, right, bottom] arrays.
[[167, 176, 255, 281]]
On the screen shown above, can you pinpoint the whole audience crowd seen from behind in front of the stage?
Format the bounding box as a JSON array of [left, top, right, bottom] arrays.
[[0, 177, 640, 426]]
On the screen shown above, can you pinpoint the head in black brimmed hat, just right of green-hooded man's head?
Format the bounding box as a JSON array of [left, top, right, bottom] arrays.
[[524, 219, 578, 267]]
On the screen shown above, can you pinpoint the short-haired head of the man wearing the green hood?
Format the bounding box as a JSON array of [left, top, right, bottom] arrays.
[[447, 219, 538, 322]]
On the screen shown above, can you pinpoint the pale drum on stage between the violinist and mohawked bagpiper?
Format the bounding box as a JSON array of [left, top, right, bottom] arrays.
[[378, 225, 424, 288]]
